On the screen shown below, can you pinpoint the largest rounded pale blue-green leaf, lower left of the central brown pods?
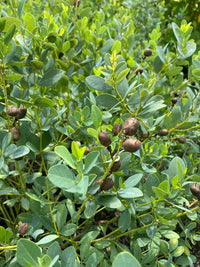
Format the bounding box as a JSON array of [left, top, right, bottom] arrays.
[[48, 165, 75, 191]]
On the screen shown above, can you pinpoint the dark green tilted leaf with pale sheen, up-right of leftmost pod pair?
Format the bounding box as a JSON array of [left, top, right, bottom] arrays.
[[38, 69, 65, 86]]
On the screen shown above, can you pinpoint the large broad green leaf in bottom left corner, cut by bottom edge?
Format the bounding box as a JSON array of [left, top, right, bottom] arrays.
[[16, 238, 42, 267]]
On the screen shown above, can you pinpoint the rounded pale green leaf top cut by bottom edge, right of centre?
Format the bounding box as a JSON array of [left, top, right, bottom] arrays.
[[112, 252, 142, 267]]
